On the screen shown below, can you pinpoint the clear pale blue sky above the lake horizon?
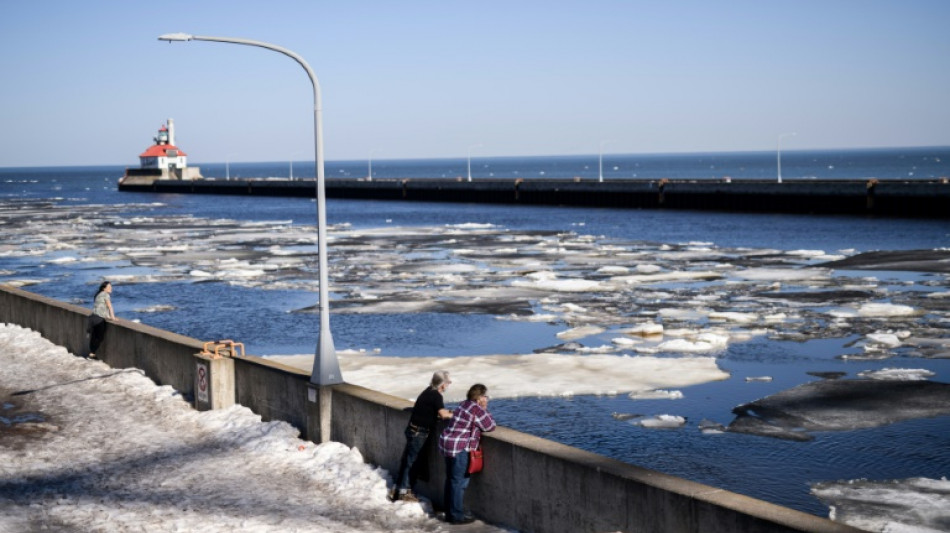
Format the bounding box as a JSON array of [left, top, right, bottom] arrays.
[[0, 0, 950, 167]]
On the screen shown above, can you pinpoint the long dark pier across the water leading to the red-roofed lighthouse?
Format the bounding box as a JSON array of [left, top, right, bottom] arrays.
[[119, 176, 950, 218]]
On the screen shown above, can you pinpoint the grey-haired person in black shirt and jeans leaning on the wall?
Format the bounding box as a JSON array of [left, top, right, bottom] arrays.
[[390, 370, 452, 502]]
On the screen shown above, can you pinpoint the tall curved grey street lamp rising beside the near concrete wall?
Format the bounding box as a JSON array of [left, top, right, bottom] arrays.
[[158, 33, 343, 385]]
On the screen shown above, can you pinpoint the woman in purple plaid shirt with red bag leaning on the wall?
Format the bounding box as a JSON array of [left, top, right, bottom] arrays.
[[439, 383, 495, 524]]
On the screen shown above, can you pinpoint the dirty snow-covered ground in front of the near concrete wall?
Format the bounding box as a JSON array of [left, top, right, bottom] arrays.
[[0, 324, 510, 533]]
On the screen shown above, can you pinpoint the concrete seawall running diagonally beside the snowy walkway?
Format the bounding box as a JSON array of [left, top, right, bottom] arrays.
[[0, 285, 860, 533]]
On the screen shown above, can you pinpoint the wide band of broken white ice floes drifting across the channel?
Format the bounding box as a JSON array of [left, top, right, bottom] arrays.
[[0, 203, 950, 370]]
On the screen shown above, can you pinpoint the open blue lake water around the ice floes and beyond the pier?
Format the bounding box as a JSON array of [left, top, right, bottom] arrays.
[[0, 148, 950, 516]]
